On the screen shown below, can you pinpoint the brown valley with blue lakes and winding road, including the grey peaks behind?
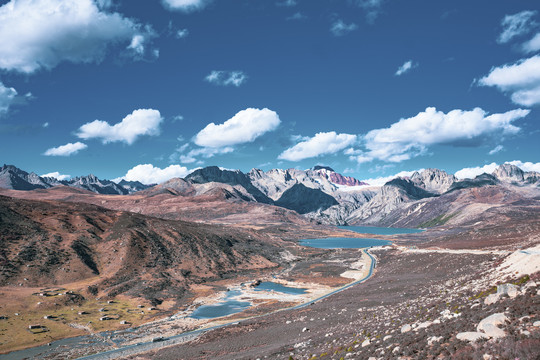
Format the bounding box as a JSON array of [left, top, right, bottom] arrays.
[[0, 165, 540, 359]]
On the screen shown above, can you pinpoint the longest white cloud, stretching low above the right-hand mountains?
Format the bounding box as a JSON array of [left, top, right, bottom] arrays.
[[359, 107, 530, 162]]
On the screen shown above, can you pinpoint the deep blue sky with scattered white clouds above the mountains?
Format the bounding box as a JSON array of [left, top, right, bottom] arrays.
[[0, 0, 540, 183]]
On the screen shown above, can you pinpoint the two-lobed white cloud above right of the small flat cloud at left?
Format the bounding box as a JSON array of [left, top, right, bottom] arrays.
[[77, 109, 163, 145]]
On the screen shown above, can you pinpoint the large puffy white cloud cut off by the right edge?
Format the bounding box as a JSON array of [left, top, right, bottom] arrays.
[[478, 55, 540, 106]]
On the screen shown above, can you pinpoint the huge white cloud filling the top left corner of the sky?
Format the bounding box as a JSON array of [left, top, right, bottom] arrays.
[[0, 0, 154, 73]]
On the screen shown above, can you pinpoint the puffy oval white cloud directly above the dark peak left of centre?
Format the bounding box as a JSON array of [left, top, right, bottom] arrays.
[[194, 108, 281, 148]]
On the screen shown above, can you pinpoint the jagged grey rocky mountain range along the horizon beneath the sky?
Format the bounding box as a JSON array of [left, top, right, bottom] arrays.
[[0, 164, 540, 226]]
